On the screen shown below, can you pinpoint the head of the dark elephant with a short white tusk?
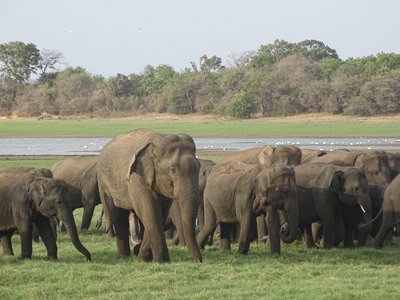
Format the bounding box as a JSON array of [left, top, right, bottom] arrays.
[[329, 167, 372, 231]]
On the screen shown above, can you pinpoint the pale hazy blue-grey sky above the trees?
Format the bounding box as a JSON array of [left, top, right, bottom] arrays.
[[0, 0, 400, 77]]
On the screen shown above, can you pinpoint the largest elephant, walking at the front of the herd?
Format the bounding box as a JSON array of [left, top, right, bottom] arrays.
[[97, 129, 202, 262]]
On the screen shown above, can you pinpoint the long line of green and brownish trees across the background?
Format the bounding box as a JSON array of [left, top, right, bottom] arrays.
[[0, 40, 400, 118]]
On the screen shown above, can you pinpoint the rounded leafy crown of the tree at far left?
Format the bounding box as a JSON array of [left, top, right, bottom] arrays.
[[0, 42, 40, 83]]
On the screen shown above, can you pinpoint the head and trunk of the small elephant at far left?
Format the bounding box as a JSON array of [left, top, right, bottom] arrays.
[[28, 177, 91, 261]]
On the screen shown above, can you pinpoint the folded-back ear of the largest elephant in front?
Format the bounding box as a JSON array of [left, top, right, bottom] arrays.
[[126, 143, 155, 186]]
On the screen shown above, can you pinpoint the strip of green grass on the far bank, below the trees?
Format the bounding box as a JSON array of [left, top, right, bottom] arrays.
[[0, 117, 400, 137]]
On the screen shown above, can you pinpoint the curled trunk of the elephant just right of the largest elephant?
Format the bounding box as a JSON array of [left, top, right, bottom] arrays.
[[280, 192, 299, 243]]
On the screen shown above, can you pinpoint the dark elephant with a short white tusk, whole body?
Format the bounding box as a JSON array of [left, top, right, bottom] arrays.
[[294, 163, 372, 248]]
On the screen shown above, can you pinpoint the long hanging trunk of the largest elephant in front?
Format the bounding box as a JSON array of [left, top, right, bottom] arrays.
[[178, 186, 202, 262]]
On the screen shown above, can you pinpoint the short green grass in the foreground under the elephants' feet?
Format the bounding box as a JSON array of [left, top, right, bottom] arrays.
[[0, 207, 400, 299]]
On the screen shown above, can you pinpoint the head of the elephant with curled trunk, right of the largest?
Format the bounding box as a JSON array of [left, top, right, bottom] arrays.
[[253, 166, 299, 243]]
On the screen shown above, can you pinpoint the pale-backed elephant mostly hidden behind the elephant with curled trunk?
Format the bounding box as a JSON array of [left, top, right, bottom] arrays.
[[225, 145, 303, 243]]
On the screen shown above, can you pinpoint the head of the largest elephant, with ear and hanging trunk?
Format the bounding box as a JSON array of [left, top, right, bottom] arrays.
[[127, 134, 201, 261]]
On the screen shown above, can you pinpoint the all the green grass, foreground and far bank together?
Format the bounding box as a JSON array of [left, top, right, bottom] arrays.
[[0, 117, 400, 300]]
